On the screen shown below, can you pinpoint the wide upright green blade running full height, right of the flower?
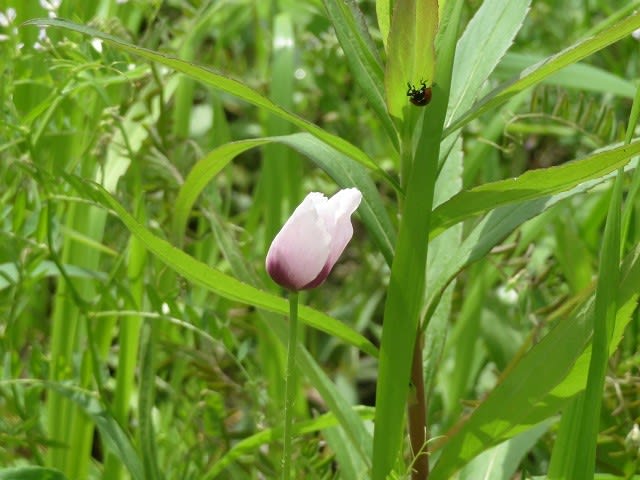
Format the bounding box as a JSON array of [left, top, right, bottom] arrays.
[[372, 0, 462, 480]]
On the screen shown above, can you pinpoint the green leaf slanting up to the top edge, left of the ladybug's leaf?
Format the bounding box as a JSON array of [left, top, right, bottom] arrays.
[[323, 0, 398, 149]]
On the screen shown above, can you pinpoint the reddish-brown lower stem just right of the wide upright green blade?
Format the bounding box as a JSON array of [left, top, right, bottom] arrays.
[[408, 332, 429, 480]]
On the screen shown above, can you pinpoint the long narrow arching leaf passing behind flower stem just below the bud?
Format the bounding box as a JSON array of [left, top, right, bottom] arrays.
[[66, 176, 377, 356]]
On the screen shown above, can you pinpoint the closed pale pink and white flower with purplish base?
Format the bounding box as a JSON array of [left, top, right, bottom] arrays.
[[266, 188, 362, 291]]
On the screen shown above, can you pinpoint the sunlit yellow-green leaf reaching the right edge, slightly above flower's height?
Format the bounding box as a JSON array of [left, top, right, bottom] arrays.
[[430, 141, 640, 238]]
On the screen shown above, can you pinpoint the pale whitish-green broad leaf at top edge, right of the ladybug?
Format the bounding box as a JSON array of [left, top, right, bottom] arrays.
[[445, 0, 531, 124]]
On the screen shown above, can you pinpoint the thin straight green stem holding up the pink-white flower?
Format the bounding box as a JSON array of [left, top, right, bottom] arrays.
[[282, 292, 298, 480]]
